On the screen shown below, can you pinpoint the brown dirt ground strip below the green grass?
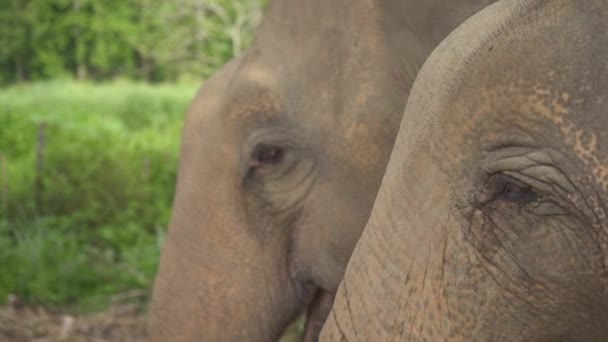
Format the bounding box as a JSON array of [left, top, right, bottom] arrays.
[[0, 300, 147, 342]]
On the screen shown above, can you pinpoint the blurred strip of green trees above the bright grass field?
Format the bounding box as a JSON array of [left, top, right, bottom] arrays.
[[0, 0, 266, 84]]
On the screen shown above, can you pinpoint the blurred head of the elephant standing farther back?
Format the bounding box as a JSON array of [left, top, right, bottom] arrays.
[[150, 0, 492, 341]]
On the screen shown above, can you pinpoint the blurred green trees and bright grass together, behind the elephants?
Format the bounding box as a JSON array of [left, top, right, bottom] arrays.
[[0, 0, 264, 311]]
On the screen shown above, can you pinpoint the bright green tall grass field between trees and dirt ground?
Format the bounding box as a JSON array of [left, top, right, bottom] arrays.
[[0, 82, 196, 310]]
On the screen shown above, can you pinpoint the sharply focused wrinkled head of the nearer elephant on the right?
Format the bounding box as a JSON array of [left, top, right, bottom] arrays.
[[321, 0, 608, 341]]
